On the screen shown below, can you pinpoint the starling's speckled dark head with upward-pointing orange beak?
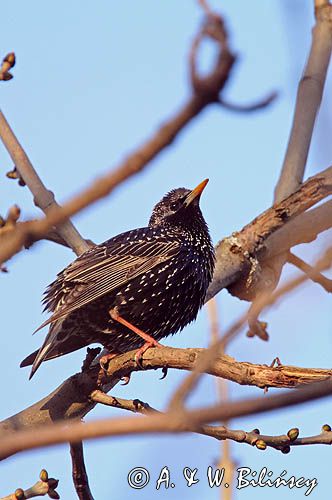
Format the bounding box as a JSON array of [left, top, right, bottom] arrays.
[[149, 179, 209, 226]]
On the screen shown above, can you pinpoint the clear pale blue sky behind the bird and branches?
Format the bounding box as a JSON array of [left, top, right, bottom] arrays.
[[0, 0, 332, 500]]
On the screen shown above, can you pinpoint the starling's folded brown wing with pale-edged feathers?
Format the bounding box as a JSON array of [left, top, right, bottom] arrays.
[[36, 233, 181, 331]]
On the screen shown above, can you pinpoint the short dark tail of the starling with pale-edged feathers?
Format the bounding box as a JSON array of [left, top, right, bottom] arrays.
[[20, 320, 89, 379]]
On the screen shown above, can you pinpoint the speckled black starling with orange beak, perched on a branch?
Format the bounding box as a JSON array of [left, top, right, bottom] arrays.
[[20, 179, 215, 378]]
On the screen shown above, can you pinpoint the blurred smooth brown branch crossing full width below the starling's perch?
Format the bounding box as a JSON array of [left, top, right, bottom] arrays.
[[0, 381, 332, 458]]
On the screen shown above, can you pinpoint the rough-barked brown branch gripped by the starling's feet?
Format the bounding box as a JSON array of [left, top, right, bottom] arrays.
[[0, 347, 332, 438]]
